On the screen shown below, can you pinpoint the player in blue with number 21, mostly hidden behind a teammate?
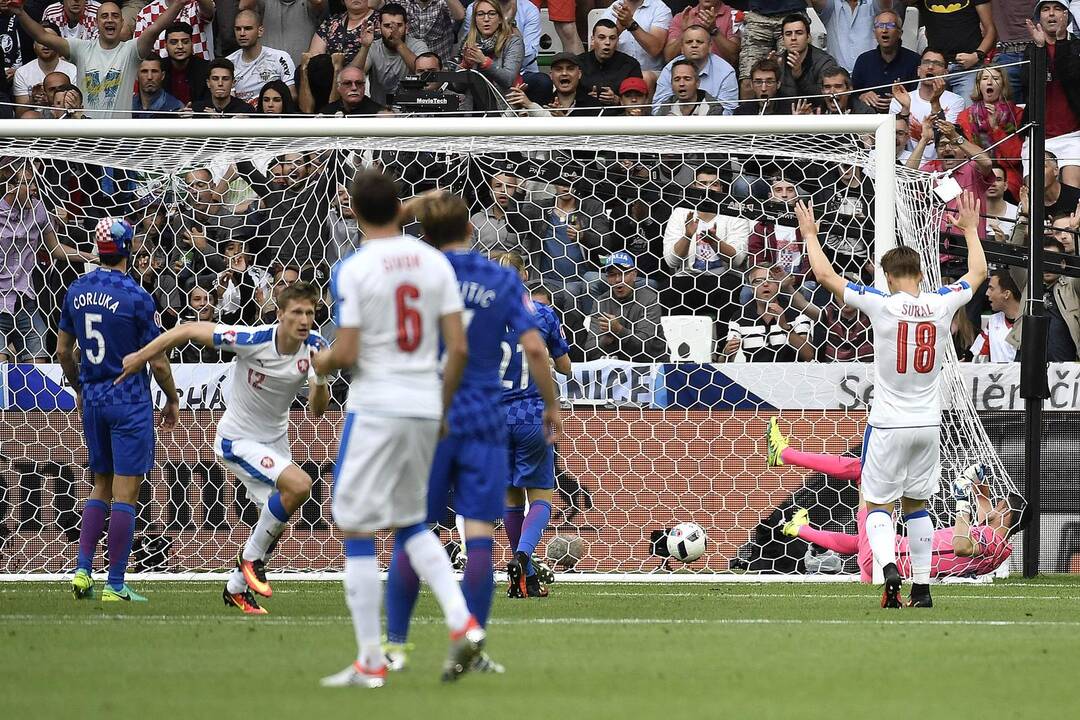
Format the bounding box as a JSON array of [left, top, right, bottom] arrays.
[[498, 253, 570, 598]]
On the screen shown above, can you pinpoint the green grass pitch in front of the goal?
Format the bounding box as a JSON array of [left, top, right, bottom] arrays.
[[0, 576, 1080, 720]]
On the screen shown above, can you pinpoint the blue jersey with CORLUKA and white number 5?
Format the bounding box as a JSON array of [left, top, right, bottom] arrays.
[[59, 268, 161, 406]]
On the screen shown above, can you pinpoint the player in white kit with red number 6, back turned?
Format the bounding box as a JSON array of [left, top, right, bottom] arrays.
[[313, 169, 486, 688]]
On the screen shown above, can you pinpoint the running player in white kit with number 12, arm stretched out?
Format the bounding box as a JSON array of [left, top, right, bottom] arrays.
[[117, 283, 330, 615]]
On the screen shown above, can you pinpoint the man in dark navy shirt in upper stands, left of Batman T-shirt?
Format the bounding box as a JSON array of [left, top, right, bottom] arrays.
[[851, 10, 919, 112]]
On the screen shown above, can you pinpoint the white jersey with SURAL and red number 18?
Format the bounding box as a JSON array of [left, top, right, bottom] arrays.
[[843, 281, 971, 427]]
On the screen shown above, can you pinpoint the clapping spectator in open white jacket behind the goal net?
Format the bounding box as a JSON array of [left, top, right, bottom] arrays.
[[662, 166, 750, 317]]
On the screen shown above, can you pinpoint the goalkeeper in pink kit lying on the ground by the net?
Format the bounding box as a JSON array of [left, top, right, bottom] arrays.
[[767, 418, 1030, 583]]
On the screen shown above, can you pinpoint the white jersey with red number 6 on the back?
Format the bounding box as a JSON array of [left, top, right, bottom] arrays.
[[330, 235, 462, 419]]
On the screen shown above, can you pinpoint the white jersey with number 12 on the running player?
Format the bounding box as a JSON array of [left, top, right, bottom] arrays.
[[214, 324, 326, 443]]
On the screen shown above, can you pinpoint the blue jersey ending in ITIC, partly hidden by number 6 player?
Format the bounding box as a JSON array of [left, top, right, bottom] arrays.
[[446, 250, 537, 443]]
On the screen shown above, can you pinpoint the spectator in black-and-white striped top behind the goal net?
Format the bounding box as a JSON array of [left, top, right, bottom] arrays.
[[718, 266, 814, 363]]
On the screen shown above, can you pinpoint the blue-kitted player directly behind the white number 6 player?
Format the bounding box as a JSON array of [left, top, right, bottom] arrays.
[[387, 192, 562, 673]]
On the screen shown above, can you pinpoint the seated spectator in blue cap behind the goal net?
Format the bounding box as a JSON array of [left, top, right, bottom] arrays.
[[585, 250, 666, 363]]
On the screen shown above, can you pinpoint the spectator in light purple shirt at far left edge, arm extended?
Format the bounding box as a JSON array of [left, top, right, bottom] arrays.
[[0, 161, 96, 363]]
